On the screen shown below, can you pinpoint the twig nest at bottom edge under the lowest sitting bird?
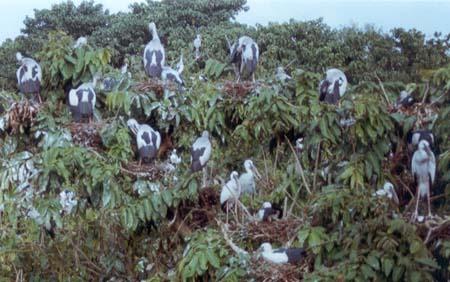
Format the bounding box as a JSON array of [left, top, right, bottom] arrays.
[[250, 258, 312, 282]]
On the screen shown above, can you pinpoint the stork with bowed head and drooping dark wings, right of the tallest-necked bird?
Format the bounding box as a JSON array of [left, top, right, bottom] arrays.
[[226, 36, 259, 82]]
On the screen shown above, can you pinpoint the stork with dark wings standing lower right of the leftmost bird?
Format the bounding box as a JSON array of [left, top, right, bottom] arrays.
[[69, 74, 99, 122]]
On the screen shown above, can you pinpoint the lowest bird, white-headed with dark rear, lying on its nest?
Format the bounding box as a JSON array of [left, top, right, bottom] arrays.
[[259, 243, 307, 264]]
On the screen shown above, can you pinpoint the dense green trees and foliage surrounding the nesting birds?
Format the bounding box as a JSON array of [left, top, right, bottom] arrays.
[[0, 0, 450, 281]]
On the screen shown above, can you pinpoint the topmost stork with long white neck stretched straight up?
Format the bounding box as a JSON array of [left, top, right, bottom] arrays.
[[144, 22, 166, 78]]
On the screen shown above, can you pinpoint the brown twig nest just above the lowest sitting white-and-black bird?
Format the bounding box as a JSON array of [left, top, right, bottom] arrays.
[[230, 219, 302, 246]]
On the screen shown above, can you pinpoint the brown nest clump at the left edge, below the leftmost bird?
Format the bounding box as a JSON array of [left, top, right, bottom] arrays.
[[6, 99, 39, 134]]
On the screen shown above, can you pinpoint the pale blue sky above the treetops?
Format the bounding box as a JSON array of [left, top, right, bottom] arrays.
[[0, 0, 450, 42]]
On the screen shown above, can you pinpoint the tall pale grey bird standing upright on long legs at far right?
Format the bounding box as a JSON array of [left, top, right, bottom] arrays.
[[411, 140, 436, 220]]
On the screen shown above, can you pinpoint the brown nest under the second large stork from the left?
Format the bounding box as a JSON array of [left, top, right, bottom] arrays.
[[69, 122, 103, 148]]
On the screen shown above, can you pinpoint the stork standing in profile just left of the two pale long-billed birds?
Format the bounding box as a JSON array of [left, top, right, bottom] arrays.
[[191, 131, 212, 187]]
